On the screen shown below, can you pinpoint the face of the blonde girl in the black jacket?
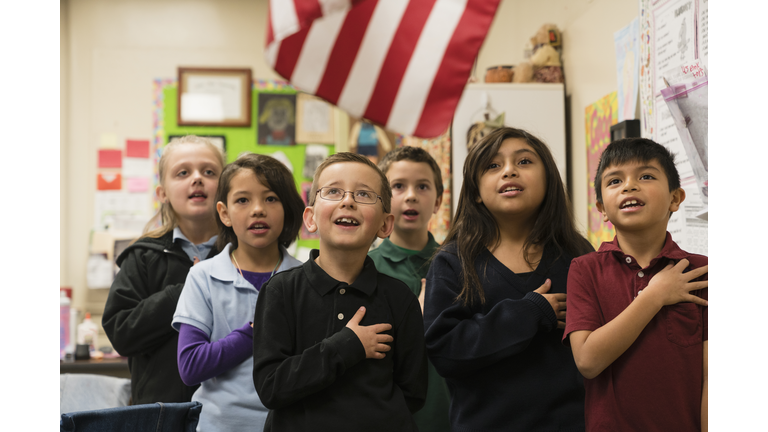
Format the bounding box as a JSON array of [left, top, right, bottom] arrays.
[[156, 144, 222, 220]]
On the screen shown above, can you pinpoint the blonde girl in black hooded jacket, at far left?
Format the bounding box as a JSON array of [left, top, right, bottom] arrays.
[[102, 135, 224, 404]]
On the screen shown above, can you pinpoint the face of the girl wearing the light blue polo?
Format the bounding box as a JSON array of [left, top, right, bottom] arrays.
[[216, 169, 285, 252]]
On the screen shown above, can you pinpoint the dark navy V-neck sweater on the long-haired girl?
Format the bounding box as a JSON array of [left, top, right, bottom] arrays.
[[424, 245, 584, 432]]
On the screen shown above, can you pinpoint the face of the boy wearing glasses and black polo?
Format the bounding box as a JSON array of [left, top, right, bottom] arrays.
[[304, 162, 393, 253]]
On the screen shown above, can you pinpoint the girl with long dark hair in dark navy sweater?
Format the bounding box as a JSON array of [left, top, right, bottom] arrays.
[[424, 128, 593, 432]]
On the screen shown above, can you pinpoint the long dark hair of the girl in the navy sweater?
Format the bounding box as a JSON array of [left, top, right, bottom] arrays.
[[440, 127, 591, 305]]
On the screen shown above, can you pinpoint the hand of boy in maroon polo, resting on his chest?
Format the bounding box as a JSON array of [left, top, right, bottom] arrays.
[[640, 259, 709, 306]]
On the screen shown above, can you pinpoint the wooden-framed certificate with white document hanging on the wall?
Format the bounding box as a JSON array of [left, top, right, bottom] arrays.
[[177, 67, 252, 127]]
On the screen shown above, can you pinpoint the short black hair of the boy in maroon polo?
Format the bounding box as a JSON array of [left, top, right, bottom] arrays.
[[595, 138, 680, 203]]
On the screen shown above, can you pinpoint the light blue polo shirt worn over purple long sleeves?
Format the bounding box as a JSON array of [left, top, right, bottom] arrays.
[[172, 243, 302, 432]]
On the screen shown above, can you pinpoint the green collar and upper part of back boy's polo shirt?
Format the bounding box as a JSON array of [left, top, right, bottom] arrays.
[[368, 232, 440, 296]]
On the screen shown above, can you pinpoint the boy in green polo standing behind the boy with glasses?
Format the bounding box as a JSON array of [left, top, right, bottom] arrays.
[[368, 146, 450, 432]]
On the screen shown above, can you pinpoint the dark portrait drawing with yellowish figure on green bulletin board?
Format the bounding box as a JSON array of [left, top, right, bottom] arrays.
[[258, 93, 296, 145]]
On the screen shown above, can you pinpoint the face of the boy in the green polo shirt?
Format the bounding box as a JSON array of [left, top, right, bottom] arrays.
[[387, 160, 442, 233]]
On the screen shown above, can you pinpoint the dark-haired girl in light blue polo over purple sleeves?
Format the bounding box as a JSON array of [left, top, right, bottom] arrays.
[[173, 154, 304, 431]]
